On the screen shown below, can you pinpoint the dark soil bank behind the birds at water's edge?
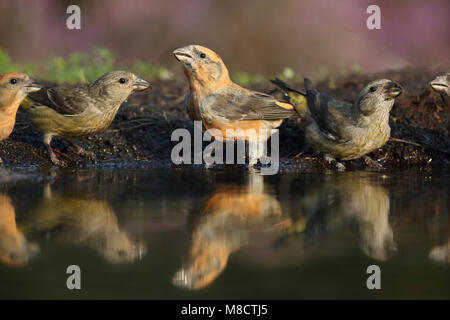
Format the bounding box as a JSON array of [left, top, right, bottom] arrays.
[[0, 68, 450, 168]]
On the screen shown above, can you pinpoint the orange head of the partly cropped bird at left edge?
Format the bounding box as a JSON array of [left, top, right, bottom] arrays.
[[0, 72, 42, 103]]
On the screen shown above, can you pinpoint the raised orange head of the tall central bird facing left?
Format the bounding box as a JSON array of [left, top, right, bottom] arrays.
[[172, 45, 230, 86]]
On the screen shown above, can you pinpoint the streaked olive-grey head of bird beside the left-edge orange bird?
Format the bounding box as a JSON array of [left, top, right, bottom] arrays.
[[90, 71, 151, 102]]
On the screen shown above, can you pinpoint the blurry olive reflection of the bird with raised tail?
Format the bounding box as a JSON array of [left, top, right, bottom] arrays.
[[290, 172, 396, 261]]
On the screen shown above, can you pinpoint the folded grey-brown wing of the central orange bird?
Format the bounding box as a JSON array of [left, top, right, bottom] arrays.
[[211, 91, 296, 121]]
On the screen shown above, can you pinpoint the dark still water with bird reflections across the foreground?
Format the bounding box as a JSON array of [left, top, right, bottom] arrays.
[[0, 168, 450, 299]]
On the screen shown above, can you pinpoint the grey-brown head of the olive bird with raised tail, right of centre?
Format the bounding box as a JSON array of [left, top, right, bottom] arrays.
[[357, 79, 403, 115]]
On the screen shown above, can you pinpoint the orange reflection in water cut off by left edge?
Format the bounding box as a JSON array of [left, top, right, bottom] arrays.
[[0, 194, 39, 267]]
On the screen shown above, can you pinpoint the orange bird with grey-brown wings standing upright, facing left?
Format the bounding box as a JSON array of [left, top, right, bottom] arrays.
[[173, 45, 297, 166]]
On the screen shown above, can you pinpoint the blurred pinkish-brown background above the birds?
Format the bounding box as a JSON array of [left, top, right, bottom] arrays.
[[0, 0, 450, 77]]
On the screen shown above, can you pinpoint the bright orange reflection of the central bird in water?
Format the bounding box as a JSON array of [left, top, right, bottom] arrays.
[[173, 174, 281, 289]]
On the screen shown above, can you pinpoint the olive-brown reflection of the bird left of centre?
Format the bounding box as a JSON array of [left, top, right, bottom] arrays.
[[27, 185, 146, 263]]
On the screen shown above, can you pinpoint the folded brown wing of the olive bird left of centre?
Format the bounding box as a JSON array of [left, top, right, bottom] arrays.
[[28, 86, 93, 115]]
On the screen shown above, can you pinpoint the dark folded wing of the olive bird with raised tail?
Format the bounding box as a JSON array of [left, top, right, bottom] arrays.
[[305, 81, 352, 141]]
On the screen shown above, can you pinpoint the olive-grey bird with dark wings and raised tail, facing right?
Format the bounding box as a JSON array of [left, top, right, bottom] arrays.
[[275, 79, 402, 170]]
